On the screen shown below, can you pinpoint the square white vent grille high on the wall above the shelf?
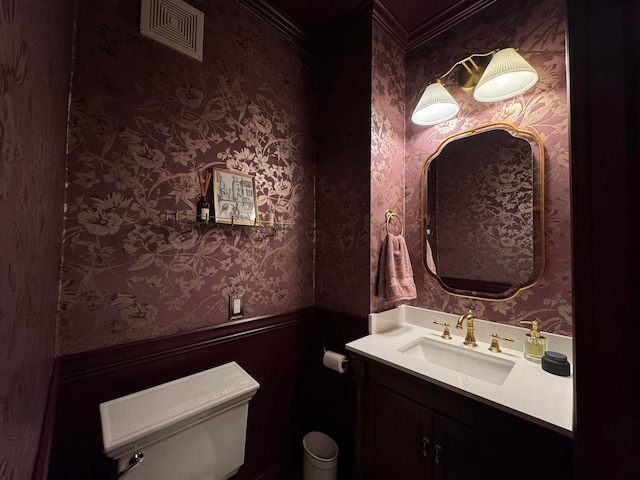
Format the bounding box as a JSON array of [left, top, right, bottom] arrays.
[[140, 0, 204, 61]]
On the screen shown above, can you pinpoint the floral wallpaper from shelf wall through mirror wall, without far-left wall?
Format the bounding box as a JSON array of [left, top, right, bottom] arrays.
[[59, 0, 571, 353]]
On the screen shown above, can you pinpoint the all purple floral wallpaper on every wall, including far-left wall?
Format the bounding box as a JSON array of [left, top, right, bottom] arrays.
[[0, 0, 572, 474]]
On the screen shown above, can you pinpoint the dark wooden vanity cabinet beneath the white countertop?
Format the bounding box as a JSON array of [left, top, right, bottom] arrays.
[[352, 355, 572, 480]]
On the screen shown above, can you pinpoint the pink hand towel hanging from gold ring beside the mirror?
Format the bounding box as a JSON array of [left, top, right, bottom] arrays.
[[376, 233, 417, 302]]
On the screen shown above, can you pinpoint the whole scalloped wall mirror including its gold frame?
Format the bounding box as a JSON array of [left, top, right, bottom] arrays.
[[421, 123, 544, 300]]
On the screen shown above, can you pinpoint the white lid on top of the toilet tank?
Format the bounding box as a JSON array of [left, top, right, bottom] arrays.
[[100, 362, 260, 453]]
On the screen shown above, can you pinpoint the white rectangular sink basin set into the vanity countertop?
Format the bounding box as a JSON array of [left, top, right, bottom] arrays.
[[398, 337, 515, 385]]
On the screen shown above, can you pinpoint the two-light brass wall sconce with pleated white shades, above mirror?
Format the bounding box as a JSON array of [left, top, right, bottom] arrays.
[[411, 48, 538, 125]]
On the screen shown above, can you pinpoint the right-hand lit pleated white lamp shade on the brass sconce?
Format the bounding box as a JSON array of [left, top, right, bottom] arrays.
[[473, 48, 538, 102]]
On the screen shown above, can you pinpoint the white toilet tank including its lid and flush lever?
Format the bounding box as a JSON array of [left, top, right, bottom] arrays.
[[100, 362, 260, 480]]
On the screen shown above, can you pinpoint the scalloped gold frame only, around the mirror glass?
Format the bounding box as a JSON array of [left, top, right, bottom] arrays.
[[420, 122, 545, 301]]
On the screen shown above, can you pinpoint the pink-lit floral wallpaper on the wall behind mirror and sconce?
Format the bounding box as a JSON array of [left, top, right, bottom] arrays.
[[405, 0, 572, 335]]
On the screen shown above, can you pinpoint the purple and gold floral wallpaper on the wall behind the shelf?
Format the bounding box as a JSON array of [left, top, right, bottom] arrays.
[[58, 0, 315, 354]]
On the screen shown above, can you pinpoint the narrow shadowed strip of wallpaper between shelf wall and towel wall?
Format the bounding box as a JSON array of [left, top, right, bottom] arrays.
[[315, 19, 371, 317]]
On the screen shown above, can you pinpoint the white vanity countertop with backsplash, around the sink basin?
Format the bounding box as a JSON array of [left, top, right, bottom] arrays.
[[346, 305, 573, 436]]
